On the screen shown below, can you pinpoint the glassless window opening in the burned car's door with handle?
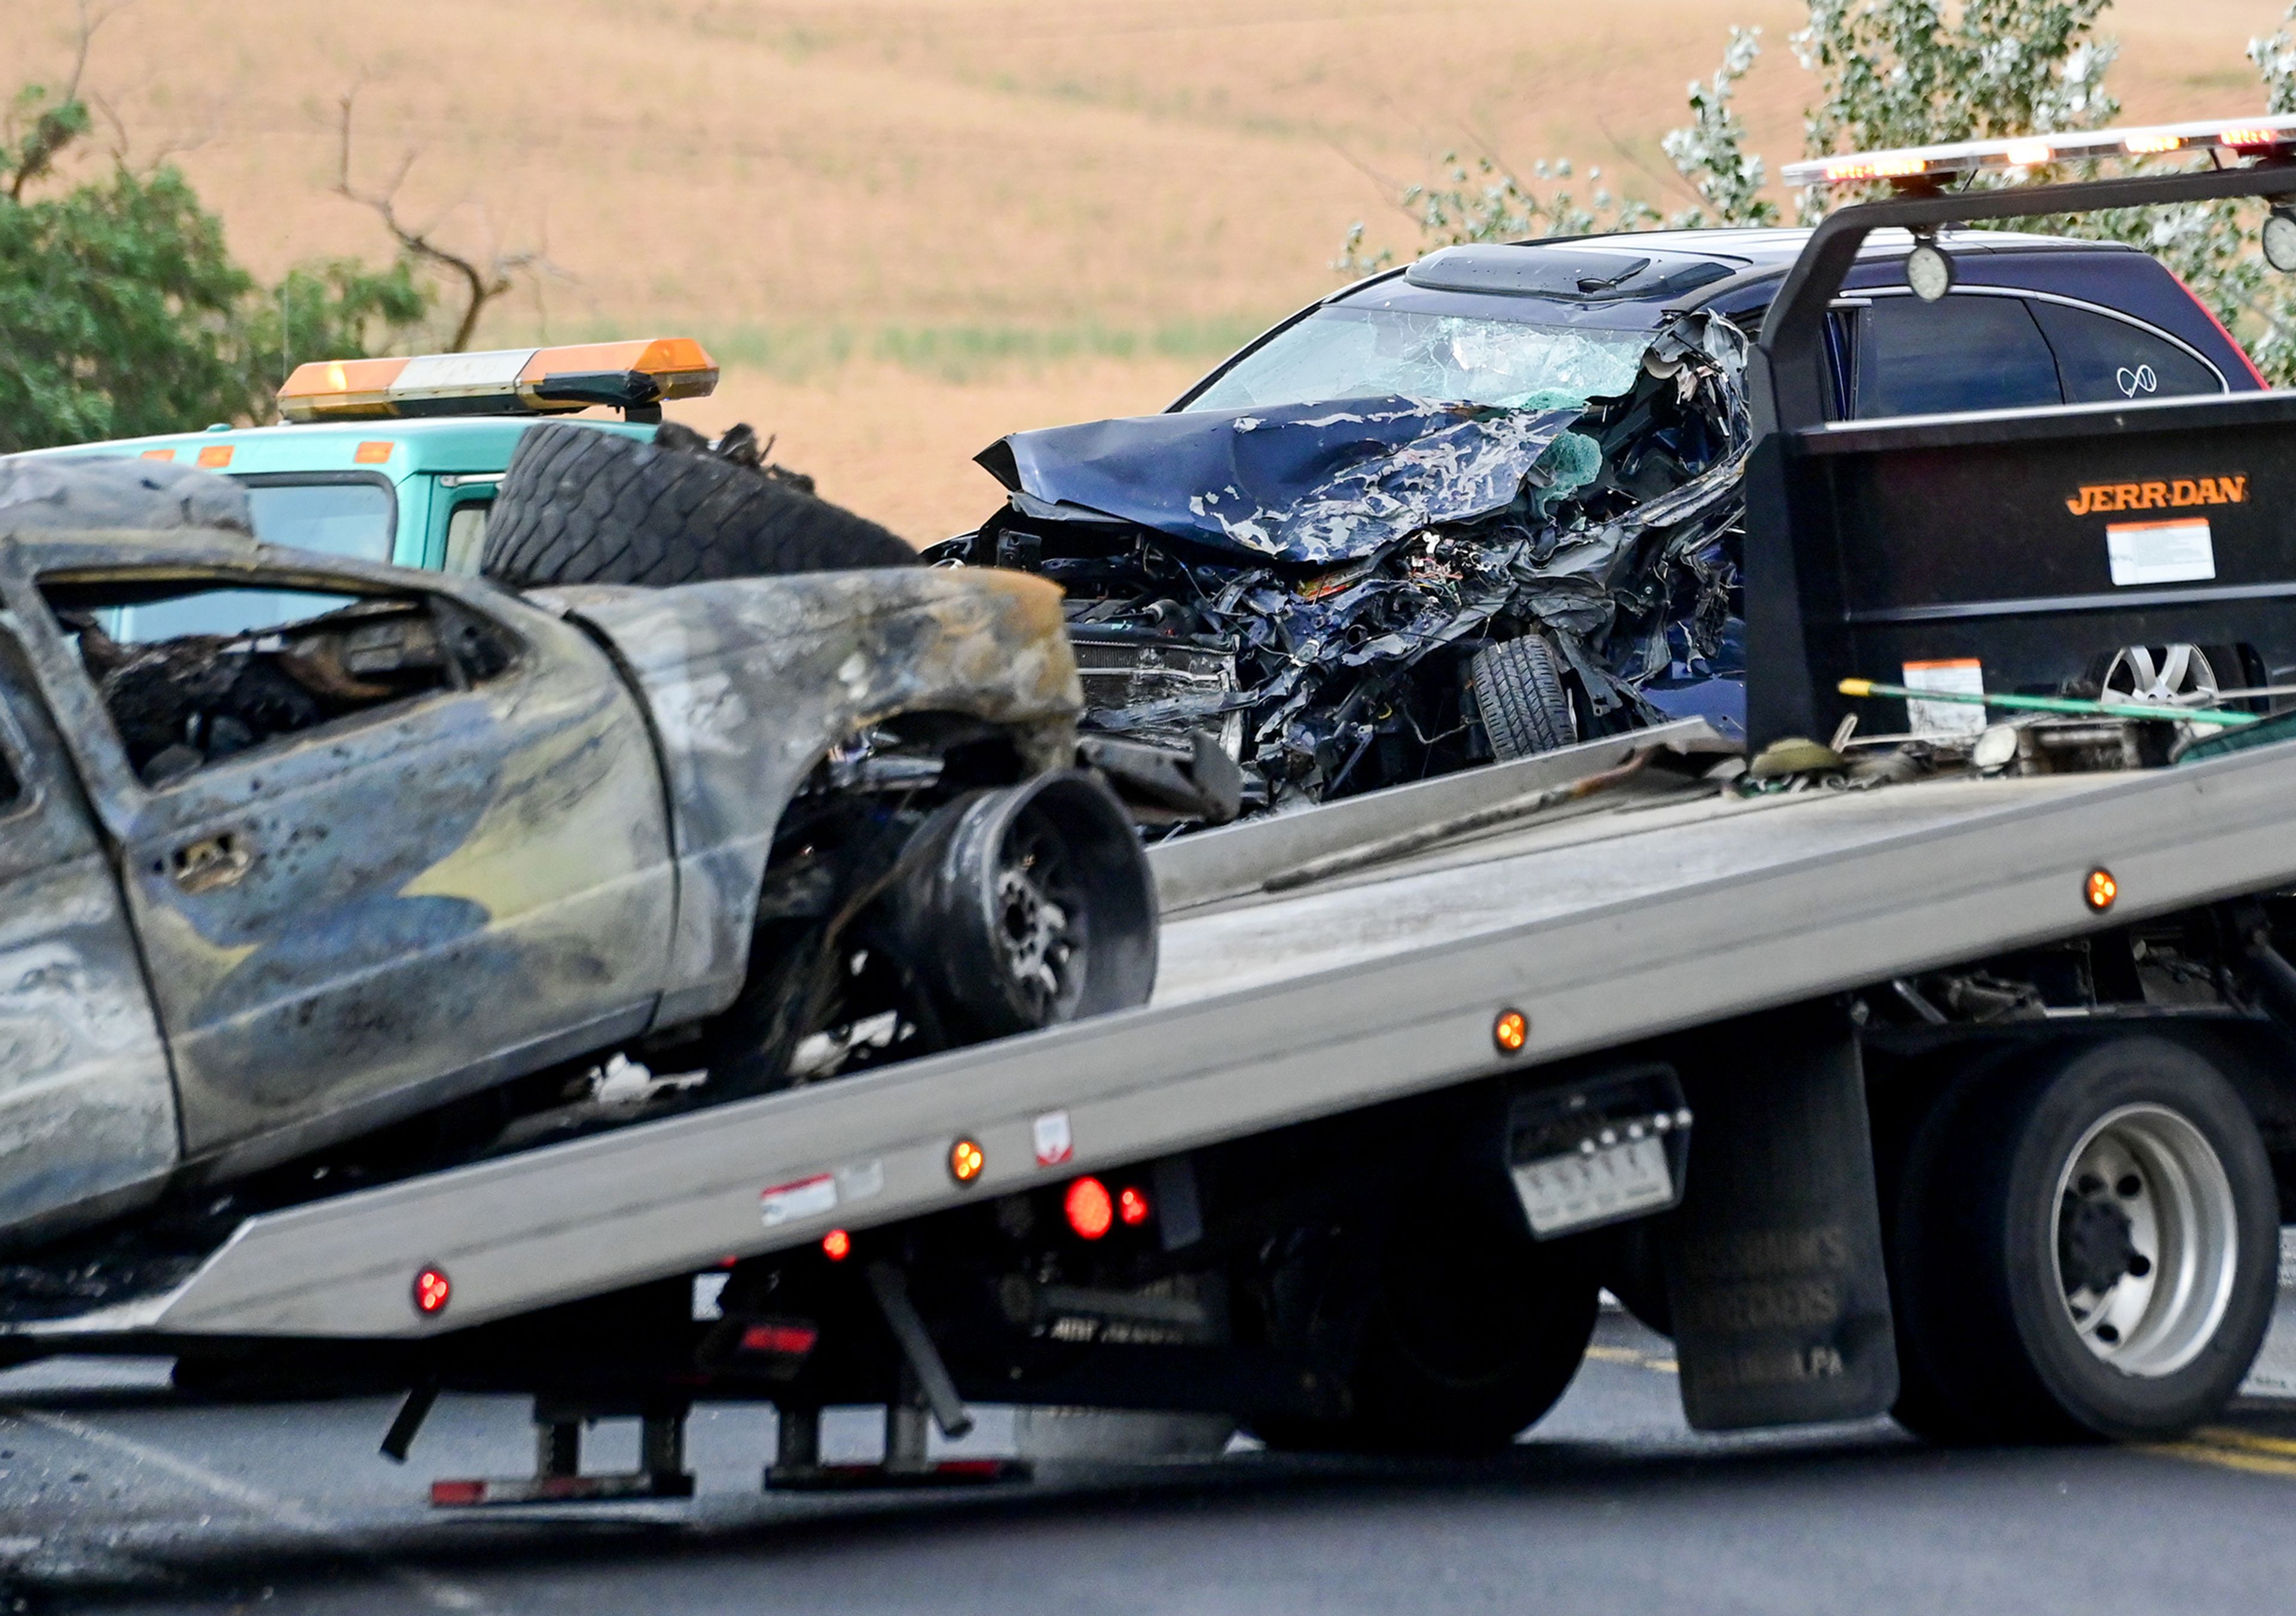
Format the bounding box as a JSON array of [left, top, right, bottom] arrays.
[[41, 578, 514, 789]]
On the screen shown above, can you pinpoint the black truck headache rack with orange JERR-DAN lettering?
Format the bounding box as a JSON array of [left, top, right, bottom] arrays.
[[1745, 161, 2296, 748]]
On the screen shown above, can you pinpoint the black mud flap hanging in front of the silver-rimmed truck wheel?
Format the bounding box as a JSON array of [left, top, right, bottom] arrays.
[[1662, 1005, 1897, 1430]]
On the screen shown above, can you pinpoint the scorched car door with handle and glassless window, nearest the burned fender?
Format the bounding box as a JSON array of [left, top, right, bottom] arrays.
[[11, 565, 675, 1169]]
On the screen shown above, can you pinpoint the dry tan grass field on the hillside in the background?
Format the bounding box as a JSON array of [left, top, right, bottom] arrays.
[[0, 0, 2280, 539]]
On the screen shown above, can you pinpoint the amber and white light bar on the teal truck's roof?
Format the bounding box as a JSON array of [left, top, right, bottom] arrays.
[[278, 337, 719, 420]]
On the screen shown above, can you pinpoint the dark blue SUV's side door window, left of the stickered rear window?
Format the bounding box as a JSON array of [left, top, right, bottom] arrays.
[[1858, 291, 2064, 418]]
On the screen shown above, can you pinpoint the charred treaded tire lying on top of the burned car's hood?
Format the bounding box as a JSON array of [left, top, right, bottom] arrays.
[[480, 420, 918, 590]]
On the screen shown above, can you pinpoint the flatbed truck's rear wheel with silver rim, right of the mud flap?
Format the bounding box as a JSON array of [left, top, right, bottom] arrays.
[[1892, 1035, 2280, 1441]]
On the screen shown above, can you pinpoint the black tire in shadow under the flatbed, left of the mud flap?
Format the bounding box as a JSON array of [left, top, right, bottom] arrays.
[[1254, 1203, 1600, 1455]]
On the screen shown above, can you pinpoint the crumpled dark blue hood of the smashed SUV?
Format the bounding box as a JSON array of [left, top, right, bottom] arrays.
[[978, 397, 1591, 565]]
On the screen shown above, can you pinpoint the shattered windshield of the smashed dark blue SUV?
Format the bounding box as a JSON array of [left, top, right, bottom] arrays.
[[1184, 303, 1651, 411]]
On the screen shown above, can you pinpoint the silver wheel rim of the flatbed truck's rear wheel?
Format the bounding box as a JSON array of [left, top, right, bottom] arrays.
[[2050, 1104, 2239, 1380]]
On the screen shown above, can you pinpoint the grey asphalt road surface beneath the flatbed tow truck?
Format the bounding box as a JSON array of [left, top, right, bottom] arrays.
[[0, 1318, 2296, 1616]]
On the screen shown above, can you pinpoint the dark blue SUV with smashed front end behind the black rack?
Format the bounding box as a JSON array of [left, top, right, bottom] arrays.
[[927, 230, 2261, 808]]
